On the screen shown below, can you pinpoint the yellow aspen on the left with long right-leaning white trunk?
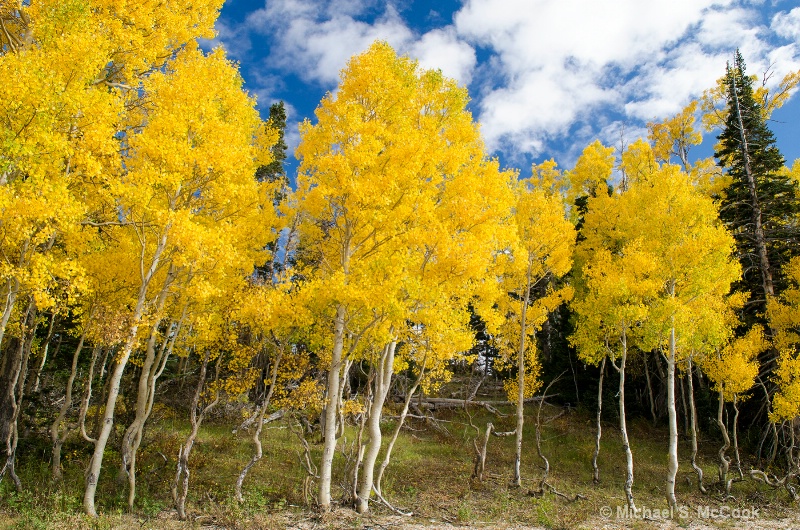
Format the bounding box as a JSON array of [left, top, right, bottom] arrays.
[[84, 48, 272, 515]]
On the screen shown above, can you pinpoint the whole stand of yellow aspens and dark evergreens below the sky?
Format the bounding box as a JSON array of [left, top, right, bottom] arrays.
[[0, 0, 800, 518]]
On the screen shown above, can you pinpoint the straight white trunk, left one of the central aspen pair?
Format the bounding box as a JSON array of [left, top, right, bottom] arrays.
[[317, 305, 345, 513]]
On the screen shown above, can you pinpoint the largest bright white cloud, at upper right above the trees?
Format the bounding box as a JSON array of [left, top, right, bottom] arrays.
[[455, 0, 800, 155]]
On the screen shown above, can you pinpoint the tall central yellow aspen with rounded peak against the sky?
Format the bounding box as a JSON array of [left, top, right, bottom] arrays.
[[297, 42, 512, 511]]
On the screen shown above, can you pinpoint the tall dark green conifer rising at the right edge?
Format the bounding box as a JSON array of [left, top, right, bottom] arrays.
[[714, 50, 798, 321]]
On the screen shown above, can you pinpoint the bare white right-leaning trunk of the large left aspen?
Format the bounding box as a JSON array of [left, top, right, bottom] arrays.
[[83, 233, 167, 517]]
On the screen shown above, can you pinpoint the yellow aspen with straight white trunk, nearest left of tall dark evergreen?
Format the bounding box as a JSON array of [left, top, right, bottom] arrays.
[[623, 161, 741, 507]]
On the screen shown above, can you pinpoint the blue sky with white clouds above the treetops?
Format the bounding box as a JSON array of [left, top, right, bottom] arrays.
[[210, 0, 800, 176]]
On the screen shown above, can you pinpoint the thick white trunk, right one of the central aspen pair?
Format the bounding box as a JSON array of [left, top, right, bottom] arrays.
[[357, 341, 397, 514]]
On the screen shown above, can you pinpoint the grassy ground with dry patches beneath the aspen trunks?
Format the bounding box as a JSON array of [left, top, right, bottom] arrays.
[[0, 398, 800, 529]]
